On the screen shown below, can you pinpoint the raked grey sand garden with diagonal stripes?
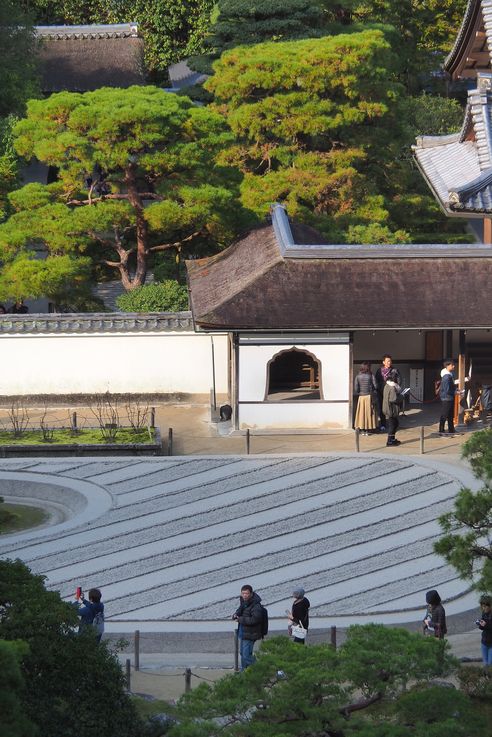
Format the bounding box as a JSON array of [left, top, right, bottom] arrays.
[[0, 453, 475, 632]]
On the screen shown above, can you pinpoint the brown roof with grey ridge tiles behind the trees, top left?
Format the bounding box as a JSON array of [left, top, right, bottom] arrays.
[[36, 23, 145, 94]]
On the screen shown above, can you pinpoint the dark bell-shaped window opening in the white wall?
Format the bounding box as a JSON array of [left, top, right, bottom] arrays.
[[265, 348, 322, 402]]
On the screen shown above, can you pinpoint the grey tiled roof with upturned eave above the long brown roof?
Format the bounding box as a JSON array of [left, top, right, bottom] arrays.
[[413, 76, 492, 217]]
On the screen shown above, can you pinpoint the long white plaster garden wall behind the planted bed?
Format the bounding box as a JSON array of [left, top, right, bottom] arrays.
[[0, 331, 228, 395]]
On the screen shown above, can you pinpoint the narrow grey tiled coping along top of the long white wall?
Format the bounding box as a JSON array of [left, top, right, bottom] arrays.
[[0, 311, 193, 339]]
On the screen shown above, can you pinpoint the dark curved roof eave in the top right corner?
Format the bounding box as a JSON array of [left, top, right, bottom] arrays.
[[444, 0, 492, 78]]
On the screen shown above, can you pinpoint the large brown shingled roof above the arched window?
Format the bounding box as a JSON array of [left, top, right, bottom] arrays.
[[186, 201, 492, 331]]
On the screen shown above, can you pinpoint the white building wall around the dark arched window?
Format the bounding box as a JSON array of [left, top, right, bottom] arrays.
[[238, 335, 351, 429]]
